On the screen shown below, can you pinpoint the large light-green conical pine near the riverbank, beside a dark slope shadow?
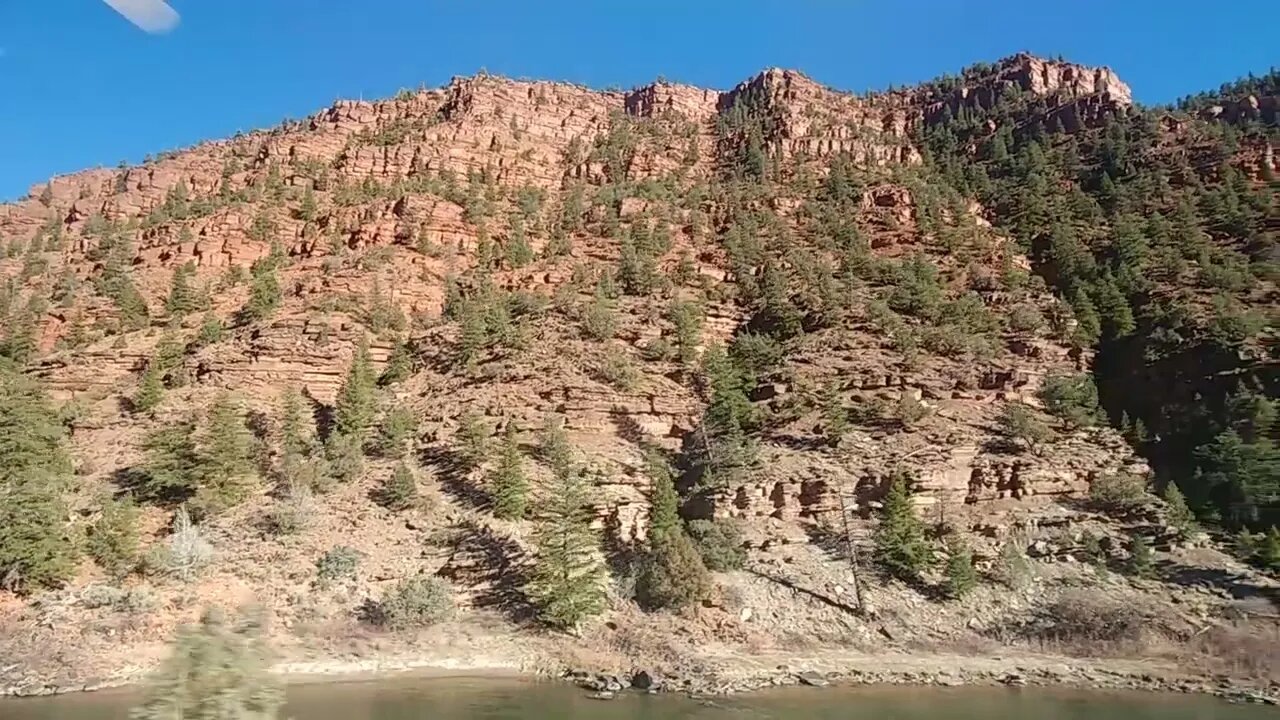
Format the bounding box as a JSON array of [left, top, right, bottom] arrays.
[[527, 458, 607, 632]]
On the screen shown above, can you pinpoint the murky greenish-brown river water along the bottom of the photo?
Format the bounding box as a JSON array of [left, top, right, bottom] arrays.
[[0, 678, 1280, 720]]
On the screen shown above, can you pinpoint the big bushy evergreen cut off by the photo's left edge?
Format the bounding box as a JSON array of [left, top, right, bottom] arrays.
[[0, 364, 77, 593]]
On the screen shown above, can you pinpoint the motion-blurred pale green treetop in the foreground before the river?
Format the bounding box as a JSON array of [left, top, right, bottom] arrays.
[[129, 610, 284, 720]]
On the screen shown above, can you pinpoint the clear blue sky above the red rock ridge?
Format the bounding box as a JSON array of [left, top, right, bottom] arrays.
[[0, 0, 1280, 199]]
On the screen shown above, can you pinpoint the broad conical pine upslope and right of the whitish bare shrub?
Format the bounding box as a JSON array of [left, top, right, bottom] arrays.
[[196, 393, 255, 512]]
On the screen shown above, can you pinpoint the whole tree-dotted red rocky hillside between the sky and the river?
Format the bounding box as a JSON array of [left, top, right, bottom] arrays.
[[0, 55, 1280, 689]]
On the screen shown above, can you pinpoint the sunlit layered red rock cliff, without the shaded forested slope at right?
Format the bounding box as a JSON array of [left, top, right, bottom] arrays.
[[0, 55, 1274, 696]]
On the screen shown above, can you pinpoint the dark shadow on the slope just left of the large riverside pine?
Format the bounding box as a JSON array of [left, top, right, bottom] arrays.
[[439, 520, 536, 623]]
